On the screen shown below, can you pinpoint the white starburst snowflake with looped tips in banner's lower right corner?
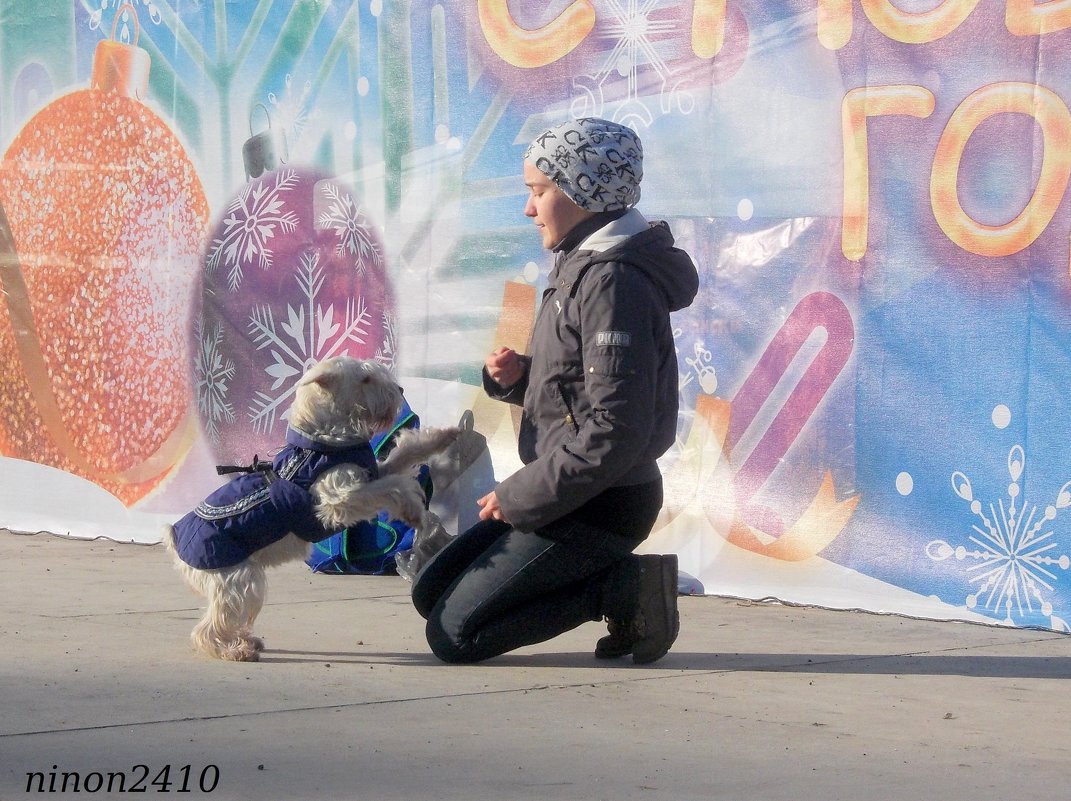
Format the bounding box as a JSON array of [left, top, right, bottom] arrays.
[[925, 444, 1071, 631]]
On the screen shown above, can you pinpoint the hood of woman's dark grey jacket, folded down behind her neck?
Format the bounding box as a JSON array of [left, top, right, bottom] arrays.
[[578, 209, 699, 312]]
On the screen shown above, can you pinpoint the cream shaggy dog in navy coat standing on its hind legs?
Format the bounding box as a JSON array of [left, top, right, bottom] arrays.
[[163, 357, 461, 662]]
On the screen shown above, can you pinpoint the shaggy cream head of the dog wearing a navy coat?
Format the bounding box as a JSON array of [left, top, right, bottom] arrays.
[[290, 356, 402, 442]]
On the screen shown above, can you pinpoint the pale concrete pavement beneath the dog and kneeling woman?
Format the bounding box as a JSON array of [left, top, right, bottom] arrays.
[[0, 530, 1071, 801]]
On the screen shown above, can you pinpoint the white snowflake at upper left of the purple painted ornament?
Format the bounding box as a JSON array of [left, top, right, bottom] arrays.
[[207, 169, 300, 291]]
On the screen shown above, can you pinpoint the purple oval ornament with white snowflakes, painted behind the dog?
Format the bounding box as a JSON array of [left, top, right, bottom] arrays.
[[192, 167, 395, 464]]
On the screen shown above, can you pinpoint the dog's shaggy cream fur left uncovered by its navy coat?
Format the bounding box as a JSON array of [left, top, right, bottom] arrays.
[[163, 357, 461, 662]]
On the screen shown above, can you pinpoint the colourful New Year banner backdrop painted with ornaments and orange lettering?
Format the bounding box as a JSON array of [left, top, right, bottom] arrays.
[[0, 0, 1071, 631]]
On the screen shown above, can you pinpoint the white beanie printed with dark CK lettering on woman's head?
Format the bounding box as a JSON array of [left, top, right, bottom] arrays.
[[525, 117, 644, 212]]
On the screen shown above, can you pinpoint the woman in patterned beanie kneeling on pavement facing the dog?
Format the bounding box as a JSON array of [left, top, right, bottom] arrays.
[[412, 118, 698, 663]]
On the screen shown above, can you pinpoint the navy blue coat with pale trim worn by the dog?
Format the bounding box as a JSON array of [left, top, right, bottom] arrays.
[[175, 428, 379, 570]]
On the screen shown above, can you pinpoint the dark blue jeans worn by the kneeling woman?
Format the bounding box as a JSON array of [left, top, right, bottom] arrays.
[[412, 482, 662, 663]]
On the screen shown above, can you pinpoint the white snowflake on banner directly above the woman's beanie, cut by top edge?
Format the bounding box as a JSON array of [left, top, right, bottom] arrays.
[[571, 0, 694, 126]]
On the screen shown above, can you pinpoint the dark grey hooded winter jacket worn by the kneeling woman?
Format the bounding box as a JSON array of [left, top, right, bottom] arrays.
[[484, 209, 699, 531]]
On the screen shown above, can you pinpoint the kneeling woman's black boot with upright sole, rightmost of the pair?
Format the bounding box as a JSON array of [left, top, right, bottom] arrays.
[[629, 554, 680, 665]]
